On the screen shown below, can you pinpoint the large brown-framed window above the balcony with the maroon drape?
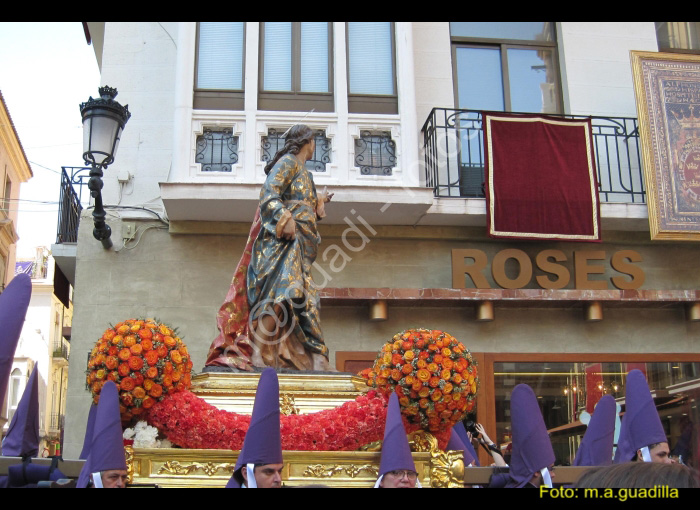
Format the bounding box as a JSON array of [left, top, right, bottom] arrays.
[[450, 22, 561, 113]]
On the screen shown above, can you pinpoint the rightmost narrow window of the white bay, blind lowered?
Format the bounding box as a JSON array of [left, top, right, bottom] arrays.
[[347, 22, 398, 114]]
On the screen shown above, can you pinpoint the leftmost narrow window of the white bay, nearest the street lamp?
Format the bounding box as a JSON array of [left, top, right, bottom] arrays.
[[193, 22, 245, 110]]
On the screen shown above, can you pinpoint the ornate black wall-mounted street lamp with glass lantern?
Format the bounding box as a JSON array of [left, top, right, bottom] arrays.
[[80, 86, 131, 249]]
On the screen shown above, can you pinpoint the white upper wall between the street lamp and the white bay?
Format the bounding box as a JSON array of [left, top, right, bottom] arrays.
[[100, 22, 178, 217]]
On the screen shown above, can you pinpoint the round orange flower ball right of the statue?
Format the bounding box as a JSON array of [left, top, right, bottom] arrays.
[[360, 329, 479, 433]]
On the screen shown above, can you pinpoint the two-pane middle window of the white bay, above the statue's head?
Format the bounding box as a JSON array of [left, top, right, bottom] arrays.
[[258, 22, 334, 112]]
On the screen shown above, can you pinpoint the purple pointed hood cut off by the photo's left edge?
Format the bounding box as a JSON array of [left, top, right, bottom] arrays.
[[0, 273, 32, 403]]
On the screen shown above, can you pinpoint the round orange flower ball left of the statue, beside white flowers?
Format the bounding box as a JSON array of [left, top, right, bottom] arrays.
[[86, 319, 192, 421]]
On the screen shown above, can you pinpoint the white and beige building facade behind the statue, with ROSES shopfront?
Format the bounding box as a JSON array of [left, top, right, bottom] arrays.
[[65, 22, 700, 463]]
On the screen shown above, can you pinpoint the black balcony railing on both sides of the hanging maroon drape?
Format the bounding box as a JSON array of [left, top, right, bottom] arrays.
[[422, 108, 645, 203]]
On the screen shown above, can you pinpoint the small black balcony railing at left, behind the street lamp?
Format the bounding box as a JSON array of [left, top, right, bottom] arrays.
[[56, 166, 90, 244]]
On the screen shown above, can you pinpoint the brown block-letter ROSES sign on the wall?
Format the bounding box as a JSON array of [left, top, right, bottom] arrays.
[[452, 248, 644, 290]]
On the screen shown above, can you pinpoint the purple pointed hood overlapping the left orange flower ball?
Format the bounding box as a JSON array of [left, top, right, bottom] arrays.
[[78, 381, 126, 487]]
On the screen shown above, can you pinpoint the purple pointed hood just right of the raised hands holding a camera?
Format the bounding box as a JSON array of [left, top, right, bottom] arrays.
[[508, 384, 555, 487]]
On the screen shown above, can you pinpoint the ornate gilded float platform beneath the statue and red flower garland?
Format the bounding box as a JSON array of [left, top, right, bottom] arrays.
[[126, 372, 464, 488]]
